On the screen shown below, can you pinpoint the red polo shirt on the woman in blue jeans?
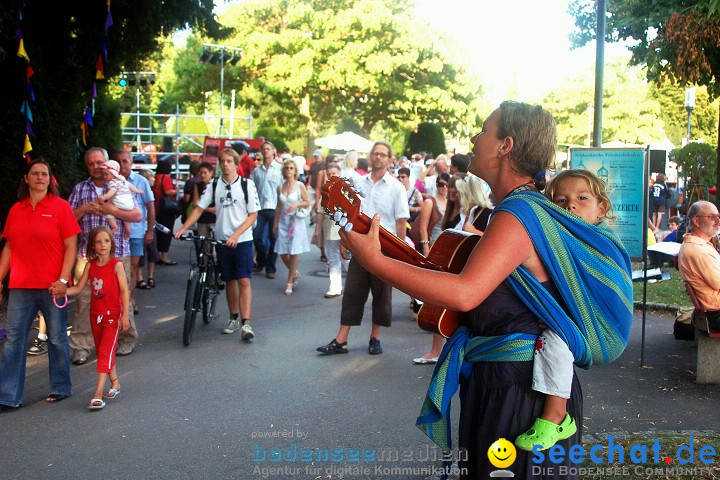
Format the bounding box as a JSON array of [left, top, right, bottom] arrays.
[[3, 193, 80, 288]]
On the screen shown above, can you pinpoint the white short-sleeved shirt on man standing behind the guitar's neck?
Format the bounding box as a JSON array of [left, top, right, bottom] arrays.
[[355, 172, 410, 235]]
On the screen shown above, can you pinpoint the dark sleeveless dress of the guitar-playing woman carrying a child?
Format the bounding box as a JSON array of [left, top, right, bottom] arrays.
[[459, 282, 583, 479]]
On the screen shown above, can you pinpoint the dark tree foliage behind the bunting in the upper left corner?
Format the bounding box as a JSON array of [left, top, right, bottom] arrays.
[[0, 0, 223, 218]]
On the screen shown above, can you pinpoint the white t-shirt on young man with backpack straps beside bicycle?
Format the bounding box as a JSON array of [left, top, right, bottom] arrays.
[[198, 176, 260, 243]]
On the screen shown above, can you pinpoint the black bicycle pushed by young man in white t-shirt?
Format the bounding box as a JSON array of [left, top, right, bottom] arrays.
[[156, 225, 225, 347]]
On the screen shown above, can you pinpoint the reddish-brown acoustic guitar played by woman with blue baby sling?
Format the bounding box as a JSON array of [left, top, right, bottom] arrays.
[[320, 176, 481, 338]]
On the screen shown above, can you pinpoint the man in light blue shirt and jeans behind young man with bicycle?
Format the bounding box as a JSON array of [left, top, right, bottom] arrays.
[[250, 142, 282, 279]]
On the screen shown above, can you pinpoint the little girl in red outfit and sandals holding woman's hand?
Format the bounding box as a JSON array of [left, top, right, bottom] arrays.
[[67, 226, 130, 410]]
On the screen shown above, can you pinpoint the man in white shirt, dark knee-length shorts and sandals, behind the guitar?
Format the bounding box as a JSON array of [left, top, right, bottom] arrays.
[[317, 142, 410, 355]]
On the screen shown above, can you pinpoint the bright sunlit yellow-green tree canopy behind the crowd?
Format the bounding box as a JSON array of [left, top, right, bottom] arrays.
[[165, 0, 480, 153]]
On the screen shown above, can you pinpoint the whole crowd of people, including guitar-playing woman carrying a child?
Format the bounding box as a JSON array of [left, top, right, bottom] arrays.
[[0, 102, 640, 478]]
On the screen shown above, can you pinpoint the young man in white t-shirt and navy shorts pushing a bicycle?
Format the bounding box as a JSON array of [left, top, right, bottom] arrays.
[[175, 148, 260, 340]]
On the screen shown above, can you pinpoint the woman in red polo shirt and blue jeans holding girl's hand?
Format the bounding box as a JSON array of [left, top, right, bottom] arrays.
[[0, 158, 80, 410]]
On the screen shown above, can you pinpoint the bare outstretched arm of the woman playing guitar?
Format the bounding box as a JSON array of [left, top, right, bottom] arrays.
[[340, 212, 548, 312]]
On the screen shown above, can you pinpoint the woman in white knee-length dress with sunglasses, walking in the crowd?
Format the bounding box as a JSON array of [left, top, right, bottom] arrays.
[[273, 159, 310, 295]]
